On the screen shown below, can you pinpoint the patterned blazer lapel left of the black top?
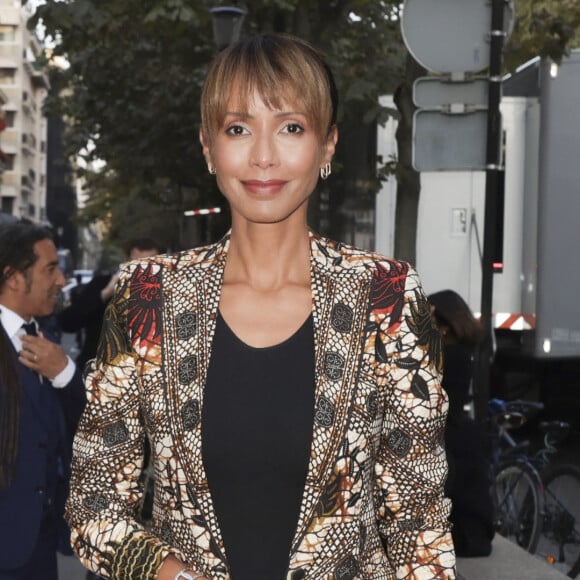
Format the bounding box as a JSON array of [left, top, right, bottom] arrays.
[[163, 238, 229, 572]]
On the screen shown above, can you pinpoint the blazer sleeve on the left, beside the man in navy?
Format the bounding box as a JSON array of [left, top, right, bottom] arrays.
[[66, 274, 183, 580]]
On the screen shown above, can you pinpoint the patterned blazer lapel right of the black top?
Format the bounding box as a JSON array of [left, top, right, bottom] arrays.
[[292, 236, 369, 554]]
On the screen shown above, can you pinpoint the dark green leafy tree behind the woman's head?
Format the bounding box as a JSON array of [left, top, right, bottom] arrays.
[[31, 0, 402, 247]]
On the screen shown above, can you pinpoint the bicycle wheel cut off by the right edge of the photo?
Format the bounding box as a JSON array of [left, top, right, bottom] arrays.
[[536, 465, 580, 578]]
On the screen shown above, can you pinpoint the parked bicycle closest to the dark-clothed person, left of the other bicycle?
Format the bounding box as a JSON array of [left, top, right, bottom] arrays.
[[489, 399, 544, 554]]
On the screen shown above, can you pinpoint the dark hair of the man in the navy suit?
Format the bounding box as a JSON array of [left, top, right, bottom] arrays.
[[0, 222, 52, 293]]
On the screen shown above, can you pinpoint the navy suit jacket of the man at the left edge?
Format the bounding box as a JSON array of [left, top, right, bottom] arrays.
[[0, 326, 85, 570]]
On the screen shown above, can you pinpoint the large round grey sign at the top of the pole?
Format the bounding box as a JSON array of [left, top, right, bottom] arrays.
[[401, 0, 513, 73]]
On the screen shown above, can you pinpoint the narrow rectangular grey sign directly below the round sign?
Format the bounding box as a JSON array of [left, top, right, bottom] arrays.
[[413, 76, 489, 110]]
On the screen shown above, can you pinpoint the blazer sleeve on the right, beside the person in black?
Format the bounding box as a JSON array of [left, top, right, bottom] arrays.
[[375, 263, 456, 580]]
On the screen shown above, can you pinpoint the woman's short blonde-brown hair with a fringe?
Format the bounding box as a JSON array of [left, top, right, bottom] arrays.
[[201, 34, 338, 143]]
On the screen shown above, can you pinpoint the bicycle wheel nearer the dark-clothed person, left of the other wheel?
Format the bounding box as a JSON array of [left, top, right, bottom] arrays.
[[493, 462, 544, 553]]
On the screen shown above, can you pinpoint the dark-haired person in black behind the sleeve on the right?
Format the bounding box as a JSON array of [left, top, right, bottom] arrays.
[[429, 290, 494, 557]]
